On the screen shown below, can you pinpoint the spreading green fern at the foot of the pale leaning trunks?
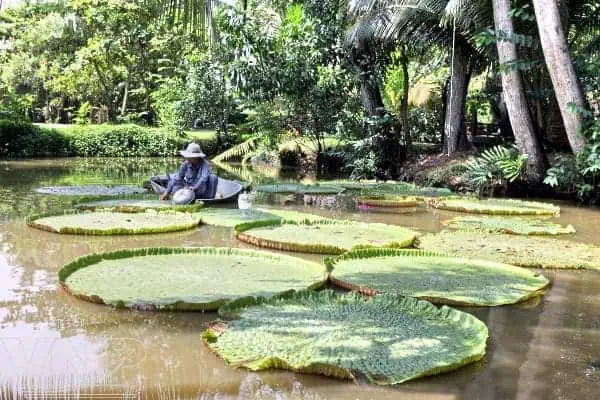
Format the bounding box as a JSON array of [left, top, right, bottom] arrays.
[[465, 145, 527, 192]]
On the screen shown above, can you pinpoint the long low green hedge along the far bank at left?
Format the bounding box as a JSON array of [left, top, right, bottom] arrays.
[[0, 120, 218, 158]]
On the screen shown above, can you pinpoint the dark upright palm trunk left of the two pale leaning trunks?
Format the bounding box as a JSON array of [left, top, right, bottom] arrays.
[[444, 40, 471, 155]]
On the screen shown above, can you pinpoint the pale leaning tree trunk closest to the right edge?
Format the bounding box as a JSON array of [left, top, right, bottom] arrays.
[[533, 0, 586, 154]]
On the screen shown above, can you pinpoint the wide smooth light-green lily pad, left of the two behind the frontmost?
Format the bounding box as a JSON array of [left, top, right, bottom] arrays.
[[59, 247, 326, 311]]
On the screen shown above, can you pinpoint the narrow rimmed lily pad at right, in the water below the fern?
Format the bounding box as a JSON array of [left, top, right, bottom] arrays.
[[429, 198, 560, 215]]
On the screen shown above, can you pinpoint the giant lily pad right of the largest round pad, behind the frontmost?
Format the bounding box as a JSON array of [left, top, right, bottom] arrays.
[[326, 249, 550, 306]]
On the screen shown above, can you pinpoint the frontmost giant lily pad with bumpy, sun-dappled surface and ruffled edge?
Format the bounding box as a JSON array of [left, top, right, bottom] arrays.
[[203, 291, 488, 385]]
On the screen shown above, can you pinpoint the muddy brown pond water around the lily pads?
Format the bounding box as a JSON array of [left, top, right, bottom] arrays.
[[0, 159, 600, 399]]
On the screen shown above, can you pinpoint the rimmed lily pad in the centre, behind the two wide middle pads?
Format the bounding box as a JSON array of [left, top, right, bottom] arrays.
[[235, 220, 416, 254]]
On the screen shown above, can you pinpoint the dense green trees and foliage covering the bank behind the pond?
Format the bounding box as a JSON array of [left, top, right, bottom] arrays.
[[0, 0, 600, 200]]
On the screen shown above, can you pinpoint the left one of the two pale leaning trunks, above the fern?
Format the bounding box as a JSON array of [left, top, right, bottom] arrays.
[[492, 0, 546, 183]]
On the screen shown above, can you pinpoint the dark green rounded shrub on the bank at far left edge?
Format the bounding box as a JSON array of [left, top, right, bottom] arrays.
[[0, 119, 72, 158]]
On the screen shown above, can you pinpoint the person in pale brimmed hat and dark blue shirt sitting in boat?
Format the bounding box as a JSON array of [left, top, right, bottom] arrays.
[[159, 143, 218, 200]]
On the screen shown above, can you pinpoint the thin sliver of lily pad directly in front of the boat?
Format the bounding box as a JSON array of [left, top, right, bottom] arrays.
[[75, 196, 202, 213]]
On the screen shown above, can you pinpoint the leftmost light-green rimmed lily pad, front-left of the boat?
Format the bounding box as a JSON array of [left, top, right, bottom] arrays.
[[27, 210, 200, 235]]
